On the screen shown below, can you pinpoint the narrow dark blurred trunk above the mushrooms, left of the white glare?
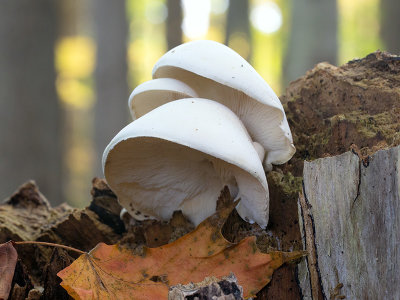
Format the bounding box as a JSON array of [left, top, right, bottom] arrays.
[[167, 0, 182, 50]]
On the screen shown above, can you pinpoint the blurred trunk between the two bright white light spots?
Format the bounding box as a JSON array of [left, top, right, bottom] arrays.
[[225, 0, 251, 61]]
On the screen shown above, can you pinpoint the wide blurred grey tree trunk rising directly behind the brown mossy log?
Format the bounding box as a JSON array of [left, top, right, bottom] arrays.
[[283, 0, 338, 86]]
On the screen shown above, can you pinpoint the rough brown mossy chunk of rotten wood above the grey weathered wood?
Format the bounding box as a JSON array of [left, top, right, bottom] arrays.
[[281, 52, 400, 169]]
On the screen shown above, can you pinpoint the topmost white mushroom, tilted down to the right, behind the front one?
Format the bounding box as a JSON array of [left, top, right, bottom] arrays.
[[153, 40, 295, 165]]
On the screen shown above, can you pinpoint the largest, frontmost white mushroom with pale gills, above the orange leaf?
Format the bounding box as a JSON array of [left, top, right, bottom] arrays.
[[103, 98, 269, 227]]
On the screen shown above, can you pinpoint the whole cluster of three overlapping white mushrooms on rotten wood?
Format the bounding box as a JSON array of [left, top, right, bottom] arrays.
[[102, 40, 295, 228]]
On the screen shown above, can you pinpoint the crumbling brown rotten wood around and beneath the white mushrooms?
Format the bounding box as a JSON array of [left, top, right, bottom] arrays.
[[0, 52, 400, 299]]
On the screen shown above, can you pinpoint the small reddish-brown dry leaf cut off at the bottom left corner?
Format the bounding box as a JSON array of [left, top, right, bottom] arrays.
[[0, 241, 18, 299]]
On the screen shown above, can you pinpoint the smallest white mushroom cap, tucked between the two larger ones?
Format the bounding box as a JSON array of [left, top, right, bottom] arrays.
[[128, 78, 197, 120]]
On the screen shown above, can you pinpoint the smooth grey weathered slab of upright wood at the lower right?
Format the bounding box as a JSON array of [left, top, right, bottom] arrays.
[[300, 146, 400, 299]]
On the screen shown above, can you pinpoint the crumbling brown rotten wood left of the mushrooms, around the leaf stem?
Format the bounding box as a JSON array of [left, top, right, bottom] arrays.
[[0, 181, 123, 299]]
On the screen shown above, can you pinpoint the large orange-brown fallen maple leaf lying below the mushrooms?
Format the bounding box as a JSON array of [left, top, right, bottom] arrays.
[[58, 198, 303, 300]]
